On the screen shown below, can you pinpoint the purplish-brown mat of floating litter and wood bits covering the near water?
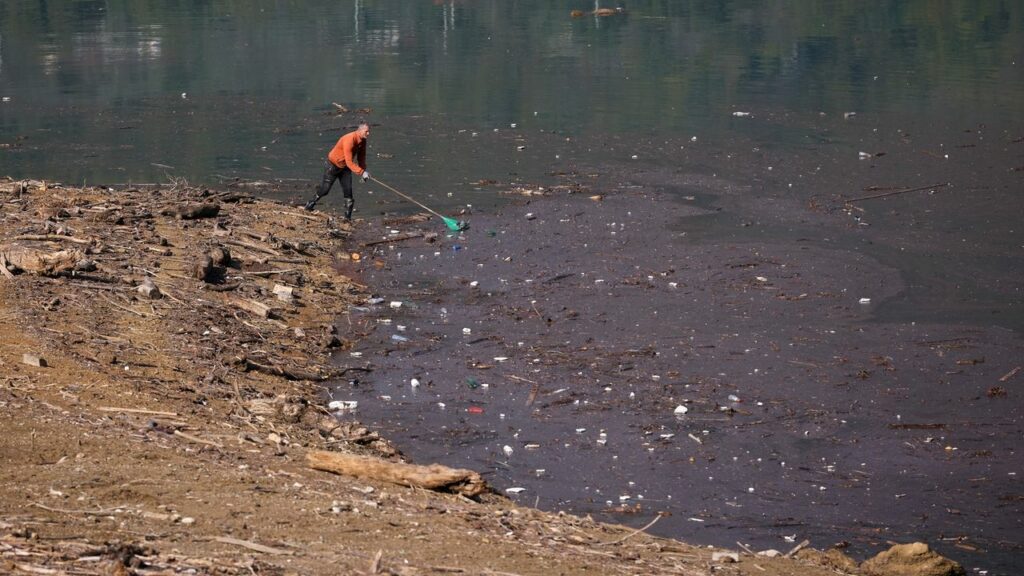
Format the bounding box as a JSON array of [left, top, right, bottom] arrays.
[[333, 169, 1024, 574]]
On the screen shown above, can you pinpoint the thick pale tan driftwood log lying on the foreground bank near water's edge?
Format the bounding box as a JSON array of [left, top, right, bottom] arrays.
[[306, 450, 487, 497]]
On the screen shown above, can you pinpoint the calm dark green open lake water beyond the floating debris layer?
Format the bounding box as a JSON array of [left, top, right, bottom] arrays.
[[0, 0, 1024, 331]]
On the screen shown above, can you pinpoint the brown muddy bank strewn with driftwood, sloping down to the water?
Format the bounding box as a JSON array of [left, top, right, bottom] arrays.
[[0, 177, 913, 576]]
